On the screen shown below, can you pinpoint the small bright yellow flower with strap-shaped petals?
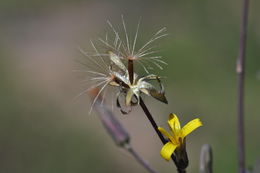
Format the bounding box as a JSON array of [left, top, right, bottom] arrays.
[[158, 114, 202, 161]]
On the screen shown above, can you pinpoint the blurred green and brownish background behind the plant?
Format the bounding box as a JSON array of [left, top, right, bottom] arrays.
[[0, 0, 260, 173]]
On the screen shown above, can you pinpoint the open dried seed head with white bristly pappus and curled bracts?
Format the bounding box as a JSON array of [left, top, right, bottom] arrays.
[[76, 16, 167, 113]]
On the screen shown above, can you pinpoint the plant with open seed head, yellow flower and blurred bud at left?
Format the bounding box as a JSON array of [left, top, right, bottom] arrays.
[[78, 16, 202, 173]]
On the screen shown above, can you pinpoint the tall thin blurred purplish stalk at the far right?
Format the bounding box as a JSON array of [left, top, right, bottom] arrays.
[[236, 0, 249, 173]]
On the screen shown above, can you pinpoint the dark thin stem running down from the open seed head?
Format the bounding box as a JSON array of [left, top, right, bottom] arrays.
[[140, 97, 186, 173]]
